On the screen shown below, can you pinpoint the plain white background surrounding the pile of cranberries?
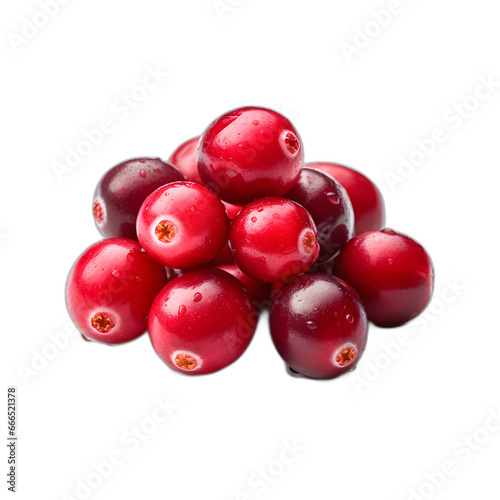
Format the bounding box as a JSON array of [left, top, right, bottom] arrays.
[[0, 0, 500, 500]]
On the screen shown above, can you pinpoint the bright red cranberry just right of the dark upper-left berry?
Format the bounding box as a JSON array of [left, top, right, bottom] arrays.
[[137, 182, 229, 269]]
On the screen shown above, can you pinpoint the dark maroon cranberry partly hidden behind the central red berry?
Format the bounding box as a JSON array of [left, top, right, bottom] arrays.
[[286, 168, 354, 264]]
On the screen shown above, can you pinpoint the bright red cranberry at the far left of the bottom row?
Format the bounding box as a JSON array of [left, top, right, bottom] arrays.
[[66, 238, 167, 344]]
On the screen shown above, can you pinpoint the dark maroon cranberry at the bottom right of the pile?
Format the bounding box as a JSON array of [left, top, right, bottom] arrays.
[[270, 273, 368, 379]]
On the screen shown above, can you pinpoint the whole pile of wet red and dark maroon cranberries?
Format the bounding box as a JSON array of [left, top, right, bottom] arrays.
[[66, 107, 433, 378]]
